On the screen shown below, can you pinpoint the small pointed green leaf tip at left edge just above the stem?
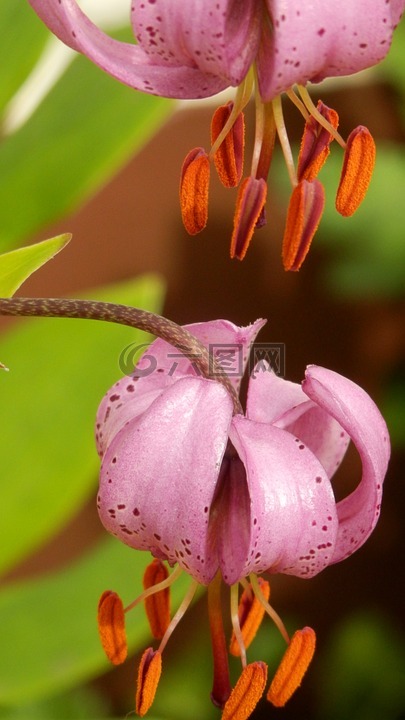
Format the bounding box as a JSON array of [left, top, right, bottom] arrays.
[[0, 233, 72, 297]]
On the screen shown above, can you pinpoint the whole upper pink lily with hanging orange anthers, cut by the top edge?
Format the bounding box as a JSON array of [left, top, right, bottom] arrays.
[[29, 0, 405, 270]]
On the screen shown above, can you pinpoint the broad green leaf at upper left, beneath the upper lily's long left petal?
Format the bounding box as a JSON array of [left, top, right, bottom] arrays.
[[0, 34, 173, 252]]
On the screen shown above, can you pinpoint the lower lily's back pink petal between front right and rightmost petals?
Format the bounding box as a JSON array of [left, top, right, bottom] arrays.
[[247, 367, 349, 478]]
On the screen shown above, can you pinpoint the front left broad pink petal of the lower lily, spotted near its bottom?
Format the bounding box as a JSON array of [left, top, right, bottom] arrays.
[[98, 377, 233, 584]]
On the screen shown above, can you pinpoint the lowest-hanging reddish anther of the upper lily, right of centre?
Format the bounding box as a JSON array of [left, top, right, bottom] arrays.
[[282, 180, 325, 270]]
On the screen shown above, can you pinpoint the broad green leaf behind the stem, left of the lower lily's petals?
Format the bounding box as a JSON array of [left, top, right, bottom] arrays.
[[0, 276, 162, 571]]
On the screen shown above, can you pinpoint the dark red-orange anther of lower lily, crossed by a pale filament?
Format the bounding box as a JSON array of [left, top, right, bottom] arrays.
[[143, 558, 170, 640]]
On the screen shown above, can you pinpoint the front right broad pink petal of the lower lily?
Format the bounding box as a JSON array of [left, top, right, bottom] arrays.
[[226, 415, 337, 582]]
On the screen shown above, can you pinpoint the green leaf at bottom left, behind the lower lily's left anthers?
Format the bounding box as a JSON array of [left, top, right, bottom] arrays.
[[0, 538, 190, 704]]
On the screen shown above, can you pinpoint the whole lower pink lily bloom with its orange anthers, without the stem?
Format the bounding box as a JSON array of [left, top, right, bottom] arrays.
[[96, 320, 390, 720]]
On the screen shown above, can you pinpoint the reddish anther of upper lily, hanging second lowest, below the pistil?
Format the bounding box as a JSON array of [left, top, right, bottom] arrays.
[[231, 177, 267, 260]]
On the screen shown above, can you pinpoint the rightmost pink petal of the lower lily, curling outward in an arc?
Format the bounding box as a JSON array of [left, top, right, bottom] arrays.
[[303, 365, 390, 563]]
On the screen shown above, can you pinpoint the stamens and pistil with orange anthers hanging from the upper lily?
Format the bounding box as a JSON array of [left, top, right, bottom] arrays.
[[180, 50, 375, 270]]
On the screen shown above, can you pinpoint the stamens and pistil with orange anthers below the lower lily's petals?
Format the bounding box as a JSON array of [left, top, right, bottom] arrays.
[[98, 560, 315, 720]]
